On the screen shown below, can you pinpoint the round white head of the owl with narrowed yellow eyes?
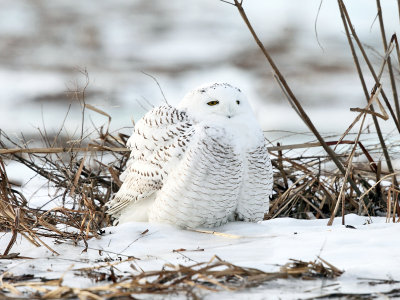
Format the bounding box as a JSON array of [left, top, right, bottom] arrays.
[[178, 83, 253, 122]]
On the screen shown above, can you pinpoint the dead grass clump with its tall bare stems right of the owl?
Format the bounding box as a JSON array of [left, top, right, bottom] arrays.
[[221, 0, 400, 225]]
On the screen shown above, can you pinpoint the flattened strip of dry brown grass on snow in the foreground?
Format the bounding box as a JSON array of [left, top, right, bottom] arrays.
[[1, 256, 343, 299]]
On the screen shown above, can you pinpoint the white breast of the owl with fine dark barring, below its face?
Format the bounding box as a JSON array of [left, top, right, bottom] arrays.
[[149, 125, 267, 227]]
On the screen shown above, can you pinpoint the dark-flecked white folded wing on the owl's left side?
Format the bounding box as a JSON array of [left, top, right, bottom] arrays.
[[107, 106, 193, 218]]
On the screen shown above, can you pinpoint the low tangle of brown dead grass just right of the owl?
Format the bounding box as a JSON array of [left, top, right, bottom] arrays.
[[265, 134, 399, 220]]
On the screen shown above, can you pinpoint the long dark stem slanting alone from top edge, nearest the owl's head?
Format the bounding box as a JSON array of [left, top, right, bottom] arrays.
[[230, 0, 361, 196]]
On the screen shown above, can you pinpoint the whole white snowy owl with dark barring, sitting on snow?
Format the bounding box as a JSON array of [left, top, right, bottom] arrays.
[[107, 83, 272, 228]]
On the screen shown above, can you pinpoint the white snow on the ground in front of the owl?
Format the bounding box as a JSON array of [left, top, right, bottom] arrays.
[[0, 215, 400, 299]]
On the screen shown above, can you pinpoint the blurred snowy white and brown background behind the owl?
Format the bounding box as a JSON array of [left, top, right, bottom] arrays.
[[0, 0, 399, 142]]
